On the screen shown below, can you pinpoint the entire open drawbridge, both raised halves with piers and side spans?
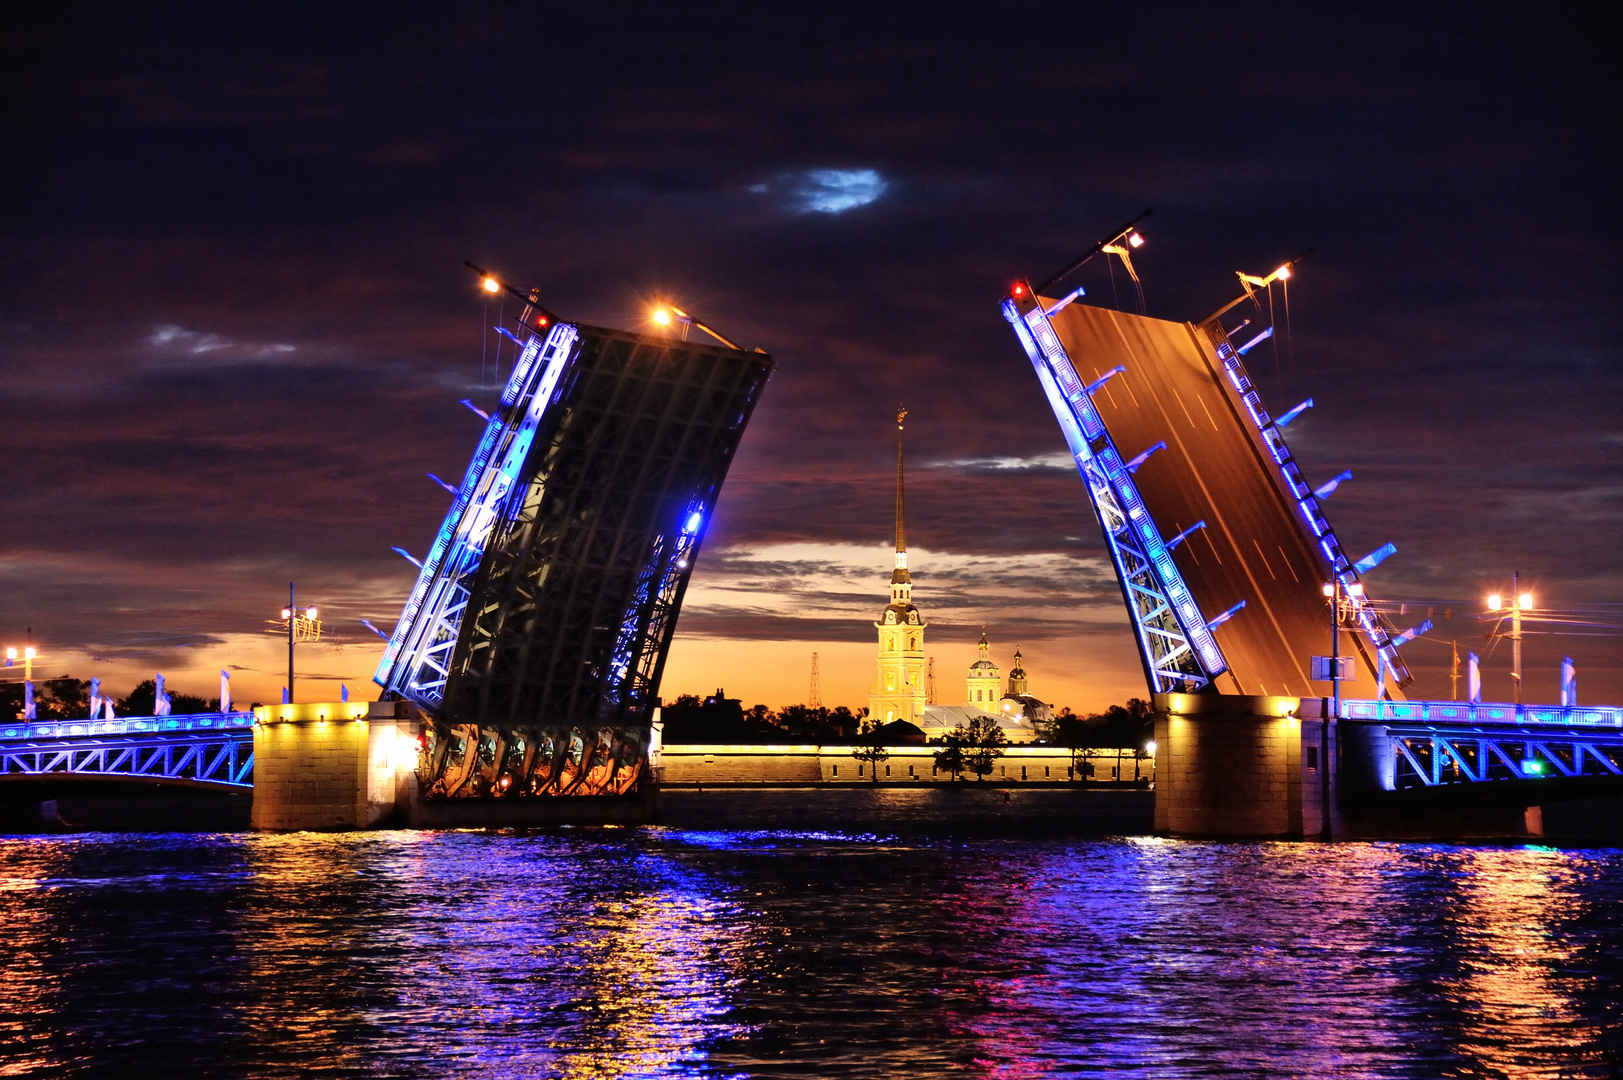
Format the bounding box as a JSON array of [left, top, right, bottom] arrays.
[[0, 238, 1623, 836]]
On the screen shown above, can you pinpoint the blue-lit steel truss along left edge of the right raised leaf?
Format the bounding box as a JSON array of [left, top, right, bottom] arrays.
[[1003, 287, 1229, 693]]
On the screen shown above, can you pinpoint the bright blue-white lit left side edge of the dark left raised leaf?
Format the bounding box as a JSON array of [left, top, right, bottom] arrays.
[[372, 323, 579, 706]]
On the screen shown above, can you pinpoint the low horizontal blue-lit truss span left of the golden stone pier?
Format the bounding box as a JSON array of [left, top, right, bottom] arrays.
[[0, 715, 253, 788]]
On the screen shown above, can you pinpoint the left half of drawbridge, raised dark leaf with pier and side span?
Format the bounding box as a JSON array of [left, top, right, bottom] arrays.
[[0, 268, 773, 828]]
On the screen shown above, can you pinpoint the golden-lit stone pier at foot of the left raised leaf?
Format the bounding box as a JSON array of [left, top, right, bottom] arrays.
[[253, 702, 419, 830]]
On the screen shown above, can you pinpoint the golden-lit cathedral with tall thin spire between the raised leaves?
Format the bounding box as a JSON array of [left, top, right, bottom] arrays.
[[868, 409, 1053, 744]]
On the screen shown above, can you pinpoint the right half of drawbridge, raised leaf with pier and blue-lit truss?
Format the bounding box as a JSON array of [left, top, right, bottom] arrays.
[[1001, 211, 1623, 838]]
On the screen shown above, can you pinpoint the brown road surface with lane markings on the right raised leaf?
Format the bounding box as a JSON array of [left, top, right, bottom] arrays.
[[1052, 304, 1375, 697]]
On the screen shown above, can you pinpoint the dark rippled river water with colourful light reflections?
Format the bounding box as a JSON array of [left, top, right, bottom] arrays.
[[0, 828, 1623, 1077]]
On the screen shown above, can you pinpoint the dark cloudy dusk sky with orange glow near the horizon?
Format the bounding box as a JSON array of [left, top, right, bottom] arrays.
[[0, 3, 1623, 710]]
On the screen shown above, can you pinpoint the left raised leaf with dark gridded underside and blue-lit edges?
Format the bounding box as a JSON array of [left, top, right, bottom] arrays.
[[375, 313, 773, 734]]
